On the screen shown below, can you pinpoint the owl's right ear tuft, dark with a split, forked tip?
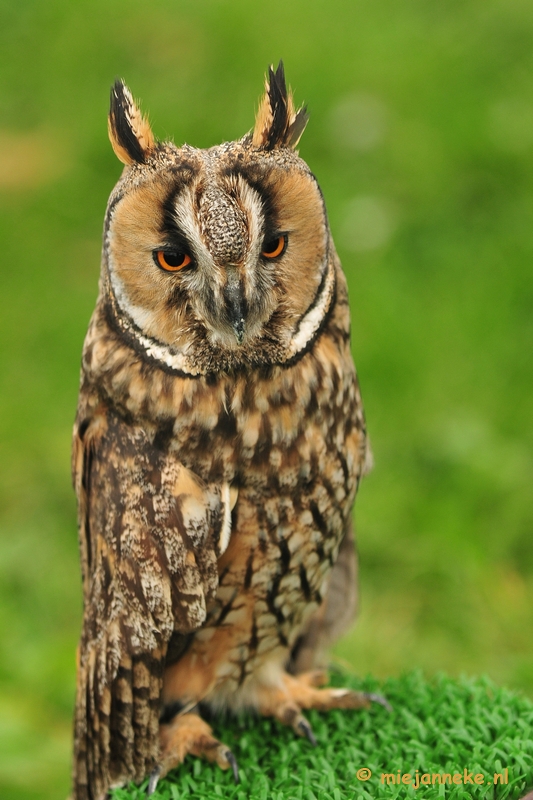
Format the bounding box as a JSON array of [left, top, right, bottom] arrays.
[[252, 61, 309, 150]]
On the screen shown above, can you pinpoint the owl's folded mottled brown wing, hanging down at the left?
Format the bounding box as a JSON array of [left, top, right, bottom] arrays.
[[70, 408, 231, 800]]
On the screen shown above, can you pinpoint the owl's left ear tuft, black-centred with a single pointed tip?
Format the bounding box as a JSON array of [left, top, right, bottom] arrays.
[[108, 80, 156, 165]]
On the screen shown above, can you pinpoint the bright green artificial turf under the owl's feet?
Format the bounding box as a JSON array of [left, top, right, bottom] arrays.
[[112, 672, 533, 800]]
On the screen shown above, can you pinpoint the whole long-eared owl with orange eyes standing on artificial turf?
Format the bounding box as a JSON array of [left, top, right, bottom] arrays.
[[73, 62, 386, 800]]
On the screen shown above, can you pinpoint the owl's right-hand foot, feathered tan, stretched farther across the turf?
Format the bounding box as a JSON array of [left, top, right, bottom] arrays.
[[258, 671, 391, 745]]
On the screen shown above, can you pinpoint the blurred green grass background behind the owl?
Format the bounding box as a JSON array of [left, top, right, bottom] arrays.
[[0, 0, 533, 800]]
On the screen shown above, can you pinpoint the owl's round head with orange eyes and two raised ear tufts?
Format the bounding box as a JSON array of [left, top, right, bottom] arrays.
[[101, 62, 334, 374]]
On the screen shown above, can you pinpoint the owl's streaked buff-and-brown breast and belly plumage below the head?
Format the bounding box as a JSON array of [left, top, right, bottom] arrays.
[[82, 282, 366, 704]]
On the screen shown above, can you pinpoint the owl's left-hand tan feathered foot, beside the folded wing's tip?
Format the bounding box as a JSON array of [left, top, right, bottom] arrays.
[[147, 713, 239, 795]]
